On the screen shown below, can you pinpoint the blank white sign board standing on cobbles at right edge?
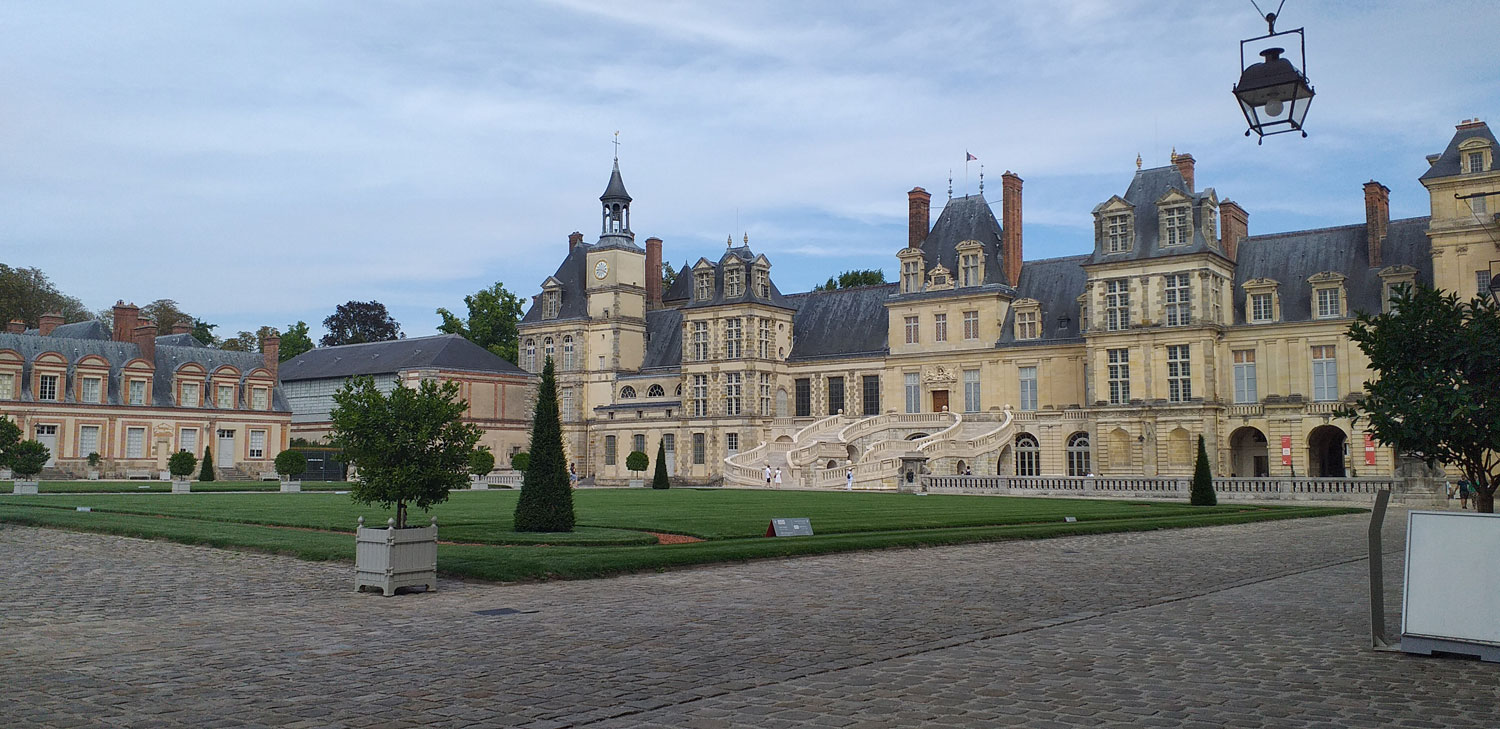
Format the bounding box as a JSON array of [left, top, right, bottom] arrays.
[[1401, 512, 1500, 645]]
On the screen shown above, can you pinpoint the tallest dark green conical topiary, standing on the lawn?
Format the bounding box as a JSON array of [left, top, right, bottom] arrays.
[[516, 357, 573, 531]]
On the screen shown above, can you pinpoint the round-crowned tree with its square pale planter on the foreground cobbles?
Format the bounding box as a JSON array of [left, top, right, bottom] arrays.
[[330, 377, 480, 596]]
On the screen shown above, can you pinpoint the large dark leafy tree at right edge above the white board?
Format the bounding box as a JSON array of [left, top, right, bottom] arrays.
[[1340, 285, 1500, 513]]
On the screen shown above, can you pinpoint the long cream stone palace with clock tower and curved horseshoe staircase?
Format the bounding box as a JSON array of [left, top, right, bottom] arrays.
[[521, 120, 1500, 488]]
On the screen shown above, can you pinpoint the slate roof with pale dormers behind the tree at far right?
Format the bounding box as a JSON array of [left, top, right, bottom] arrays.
[[1235, 218, 1433, 324]]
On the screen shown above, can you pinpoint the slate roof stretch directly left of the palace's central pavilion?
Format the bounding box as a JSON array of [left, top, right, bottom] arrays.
[[786, 284, 900, 362]]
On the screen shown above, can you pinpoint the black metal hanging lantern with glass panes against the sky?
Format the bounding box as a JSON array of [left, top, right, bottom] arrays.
[[1235, 12, 1313, 144]]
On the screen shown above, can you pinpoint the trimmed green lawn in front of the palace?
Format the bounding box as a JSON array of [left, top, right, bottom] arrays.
[[0, 485, 1359, 581]]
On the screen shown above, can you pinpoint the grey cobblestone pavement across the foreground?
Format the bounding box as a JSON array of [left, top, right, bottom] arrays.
[[0, 512, 1500, 728]]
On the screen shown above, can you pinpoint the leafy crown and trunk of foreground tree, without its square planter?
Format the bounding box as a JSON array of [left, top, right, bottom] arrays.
[[329, 377, 480, 528]]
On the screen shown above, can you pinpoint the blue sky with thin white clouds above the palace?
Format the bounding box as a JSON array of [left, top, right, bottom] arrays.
[[0, 0, 1500, 342]]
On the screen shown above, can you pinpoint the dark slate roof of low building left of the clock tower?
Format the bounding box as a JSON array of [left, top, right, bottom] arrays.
[[281, 335, 534, 383]]
